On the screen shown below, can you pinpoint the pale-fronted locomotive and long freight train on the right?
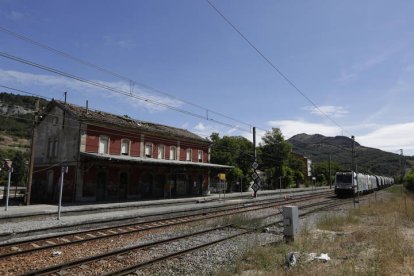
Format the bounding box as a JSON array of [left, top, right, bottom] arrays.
[[335, 171, 394, 197]]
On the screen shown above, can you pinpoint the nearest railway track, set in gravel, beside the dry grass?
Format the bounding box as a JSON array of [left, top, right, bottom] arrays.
[[24, 197, 349, 275]]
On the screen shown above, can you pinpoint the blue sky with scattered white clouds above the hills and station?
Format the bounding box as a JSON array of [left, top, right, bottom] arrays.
[[0, 0, 414, 155]]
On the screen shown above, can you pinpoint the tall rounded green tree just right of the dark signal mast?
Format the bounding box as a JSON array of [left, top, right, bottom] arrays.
[[259, 128, 292, 188]]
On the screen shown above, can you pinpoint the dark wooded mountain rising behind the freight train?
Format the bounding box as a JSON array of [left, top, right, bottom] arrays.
[[287, 133, 414, 176]]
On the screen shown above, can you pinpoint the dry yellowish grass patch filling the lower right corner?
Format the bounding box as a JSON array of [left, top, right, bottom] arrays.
[[219, 187, 414, 275]]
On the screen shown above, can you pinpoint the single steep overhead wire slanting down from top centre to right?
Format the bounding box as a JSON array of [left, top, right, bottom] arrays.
[[206, 0, 351, 136]]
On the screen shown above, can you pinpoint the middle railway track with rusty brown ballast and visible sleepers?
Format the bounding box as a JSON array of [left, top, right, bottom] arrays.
[[0, 193, 334, 272]]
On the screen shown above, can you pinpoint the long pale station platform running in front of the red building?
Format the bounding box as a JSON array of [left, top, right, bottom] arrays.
[[0, 187, 333, 243]]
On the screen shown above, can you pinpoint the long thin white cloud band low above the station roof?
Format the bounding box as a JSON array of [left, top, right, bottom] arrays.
[[0, 69, 183, 112]]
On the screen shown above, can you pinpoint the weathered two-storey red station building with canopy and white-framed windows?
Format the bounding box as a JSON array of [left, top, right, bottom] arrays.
[[32, 101, 230, 202]]
